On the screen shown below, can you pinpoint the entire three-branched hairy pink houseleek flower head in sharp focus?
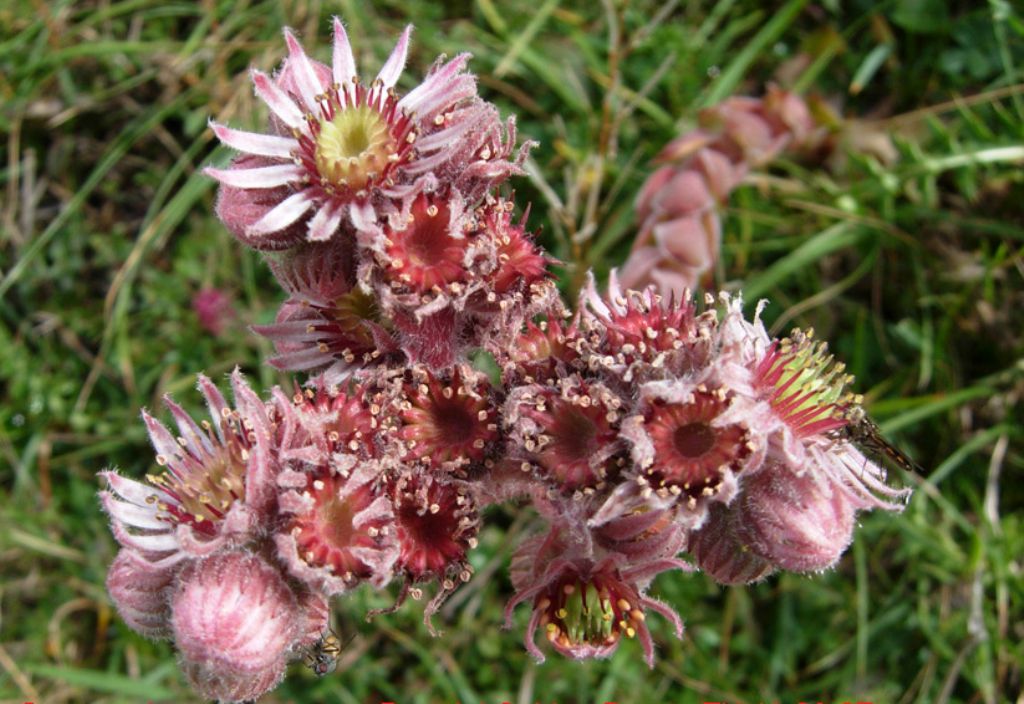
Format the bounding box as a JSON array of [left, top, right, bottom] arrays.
[[101, 21, 904, 701]]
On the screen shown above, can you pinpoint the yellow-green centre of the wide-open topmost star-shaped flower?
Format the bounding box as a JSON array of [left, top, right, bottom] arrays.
[[315, 105, 397, 190]]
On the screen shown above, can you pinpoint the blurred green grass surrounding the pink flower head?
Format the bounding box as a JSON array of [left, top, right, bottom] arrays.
[[0, 0, 1024, 704]]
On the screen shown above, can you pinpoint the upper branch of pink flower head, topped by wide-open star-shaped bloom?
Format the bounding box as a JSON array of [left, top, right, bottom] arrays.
[[207, 19, 557, 374]]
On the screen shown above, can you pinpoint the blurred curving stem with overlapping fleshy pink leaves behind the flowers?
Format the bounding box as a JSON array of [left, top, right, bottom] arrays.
[[622, 86, 815, 296]]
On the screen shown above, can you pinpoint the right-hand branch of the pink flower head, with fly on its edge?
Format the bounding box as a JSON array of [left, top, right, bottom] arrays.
[[484, 275, 907, 661]]
